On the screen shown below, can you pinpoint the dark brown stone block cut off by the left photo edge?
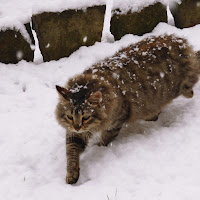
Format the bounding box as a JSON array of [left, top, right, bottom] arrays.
[[0, 24, 34, 64]]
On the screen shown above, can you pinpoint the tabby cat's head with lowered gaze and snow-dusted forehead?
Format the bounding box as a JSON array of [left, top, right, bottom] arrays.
[[56, 86, 106, 133]]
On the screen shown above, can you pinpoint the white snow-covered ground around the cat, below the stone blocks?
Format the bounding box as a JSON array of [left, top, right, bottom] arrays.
[[0, 23, 200, 200]]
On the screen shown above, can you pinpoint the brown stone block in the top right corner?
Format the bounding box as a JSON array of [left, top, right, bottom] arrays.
[[171, 0, 200, 28]]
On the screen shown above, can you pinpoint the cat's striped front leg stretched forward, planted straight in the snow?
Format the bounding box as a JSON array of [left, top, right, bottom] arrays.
[[66, 136, 86, 184]]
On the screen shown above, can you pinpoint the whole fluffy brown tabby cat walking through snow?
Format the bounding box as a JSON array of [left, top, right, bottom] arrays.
[[56, 35, 200, 184]]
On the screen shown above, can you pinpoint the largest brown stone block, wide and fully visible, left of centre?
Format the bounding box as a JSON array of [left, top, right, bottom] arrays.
[[32, 6, 106, 61]]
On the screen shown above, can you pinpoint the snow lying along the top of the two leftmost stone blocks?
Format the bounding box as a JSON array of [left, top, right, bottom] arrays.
[[0, 0, 106, 23]]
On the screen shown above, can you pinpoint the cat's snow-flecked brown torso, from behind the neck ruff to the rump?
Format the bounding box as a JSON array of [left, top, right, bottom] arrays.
[[86, 35, 199, 118]]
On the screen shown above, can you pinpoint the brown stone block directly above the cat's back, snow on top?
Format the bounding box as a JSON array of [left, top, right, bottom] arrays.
[[111, 2, 167, 40]]
